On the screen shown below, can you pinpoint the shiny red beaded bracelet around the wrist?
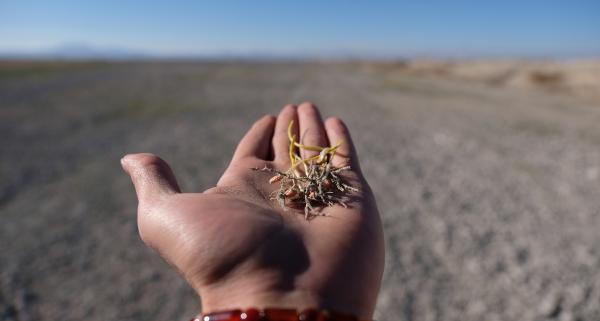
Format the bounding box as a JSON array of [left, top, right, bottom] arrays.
[[191, 308, 367, 321]]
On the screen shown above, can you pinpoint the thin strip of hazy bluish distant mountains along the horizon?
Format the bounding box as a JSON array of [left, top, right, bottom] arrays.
[[0, 42, 600, 60]]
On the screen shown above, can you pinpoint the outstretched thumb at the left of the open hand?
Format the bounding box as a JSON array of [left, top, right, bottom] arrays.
[[121, 153, 181, 203]]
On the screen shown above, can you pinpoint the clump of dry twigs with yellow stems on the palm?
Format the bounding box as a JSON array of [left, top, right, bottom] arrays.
[[252, 121, 358, 220]]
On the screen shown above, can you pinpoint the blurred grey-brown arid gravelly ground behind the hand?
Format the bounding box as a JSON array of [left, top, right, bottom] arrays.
[[0, 61, 600, 321]]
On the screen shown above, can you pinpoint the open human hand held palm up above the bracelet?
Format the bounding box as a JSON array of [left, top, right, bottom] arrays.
[[121, 103, 384, 318]]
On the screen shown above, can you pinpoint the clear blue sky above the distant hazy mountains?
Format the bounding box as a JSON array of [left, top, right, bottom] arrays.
[[0, 0, 600, 57]]
